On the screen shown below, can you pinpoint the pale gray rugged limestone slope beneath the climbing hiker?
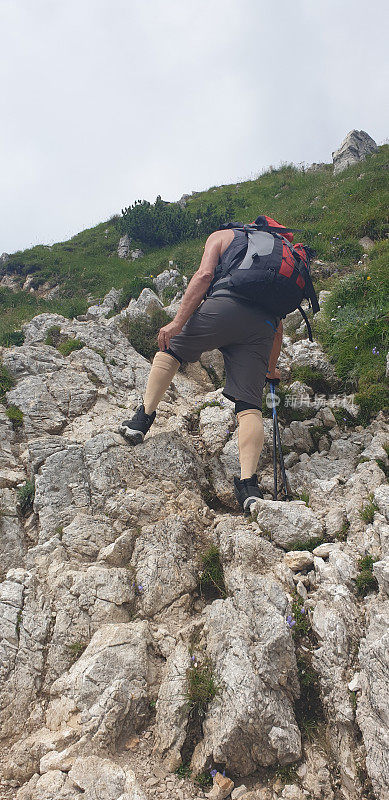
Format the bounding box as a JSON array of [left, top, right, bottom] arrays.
[[0, 288, 389, 800]]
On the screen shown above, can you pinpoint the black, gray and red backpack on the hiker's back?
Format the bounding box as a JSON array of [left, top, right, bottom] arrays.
[[207, 215, 320, 341]]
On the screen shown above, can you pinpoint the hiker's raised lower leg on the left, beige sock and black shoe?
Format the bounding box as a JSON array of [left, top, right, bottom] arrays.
[[119, 351, 180, 444]]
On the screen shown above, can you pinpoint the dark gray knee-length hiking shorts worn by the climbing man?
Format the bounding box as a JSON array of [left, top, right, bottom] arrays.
[[169, 296, 280, 408]]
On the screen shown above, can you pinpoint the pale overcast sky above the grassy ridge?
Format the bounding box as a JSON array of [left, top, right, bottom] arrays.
[[0, 0, 389, 253]]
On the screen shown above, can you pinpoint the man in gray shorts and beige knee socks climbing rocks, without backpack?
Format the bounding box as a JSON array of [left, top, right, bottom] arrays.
[[119, 222, 282, 513]]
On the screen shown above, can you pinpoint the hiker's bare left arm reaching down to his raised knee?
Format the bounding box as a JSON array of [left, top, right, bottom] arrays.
[[158, 231, 222, 350]]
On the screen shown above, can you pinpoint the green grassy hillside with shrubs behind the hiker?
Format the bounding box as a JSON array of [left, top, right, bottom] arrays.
[[0, 145, 389, 418]]
